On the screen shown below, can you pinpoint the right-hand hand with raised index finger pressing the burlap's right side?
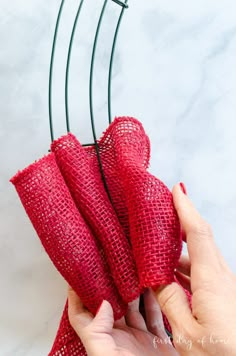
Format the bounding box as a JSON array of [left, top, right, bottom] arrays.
[[156, 185, 236, 356]]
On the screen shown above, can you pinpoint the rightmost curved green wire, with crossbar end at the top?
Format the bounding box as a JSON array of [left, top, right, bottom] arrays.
[[108, 0, 128, 124]]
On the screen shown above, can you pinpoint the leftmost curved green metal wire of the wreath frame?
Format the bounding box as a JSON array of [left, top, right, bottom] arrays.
[[48, 0, 65, 141]]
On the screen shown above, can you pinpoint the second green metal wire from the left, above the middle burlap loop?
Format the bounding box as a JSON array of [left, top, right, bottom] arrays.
[[65, 0, 84, 132]]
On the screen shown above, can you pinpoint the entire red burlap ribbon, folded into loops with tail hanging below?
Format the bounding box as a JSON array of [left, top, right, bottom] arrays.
[[11, 117, 182, 356]]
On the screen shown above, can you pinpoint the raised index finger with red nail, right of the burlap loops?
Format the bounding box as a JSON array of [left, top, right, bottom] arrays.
[[173, 184, 218, 268]]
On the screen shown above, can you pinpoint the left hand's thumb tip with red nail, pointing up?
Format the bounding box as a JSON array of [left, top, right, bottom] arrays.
[[90, 300, 114, 334]]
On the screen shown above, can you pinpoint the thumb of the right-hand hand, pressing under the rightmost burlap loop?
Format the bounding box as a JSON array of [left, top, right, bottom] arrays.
[[155, 282, 195, 335]]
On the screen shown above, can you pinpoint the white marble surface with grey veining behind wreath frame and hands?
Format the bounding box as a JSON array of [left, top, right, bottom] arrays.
[[0, 0, 236, 356]]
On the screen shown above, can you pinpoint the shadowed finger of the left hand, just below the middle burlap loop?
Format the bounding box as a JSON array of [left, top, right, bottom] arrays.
[[125, 298, 147, 331]]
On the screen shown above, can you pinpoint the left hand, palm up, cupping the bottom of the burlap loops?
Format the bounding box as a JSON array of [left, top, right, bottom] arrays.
[[68, 289, 178, 356]]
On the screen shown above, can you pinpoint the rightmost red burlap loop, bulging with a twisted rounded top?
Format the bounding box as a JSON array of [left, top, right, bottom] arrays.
[[89, 118, 182, 287]]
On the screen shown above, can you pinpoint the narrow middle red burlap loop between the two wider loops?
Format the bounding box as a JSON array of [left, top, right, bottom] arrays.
[[52, 134, 140, 303]]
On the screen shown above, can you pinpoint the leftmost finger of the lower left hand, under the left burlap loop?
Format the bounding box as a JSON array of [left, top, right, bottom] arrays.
[[68, 287, 93, 335]]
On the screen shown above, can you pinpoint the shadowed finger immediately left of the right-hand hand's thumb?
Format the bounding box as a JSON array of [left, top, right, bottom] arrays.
[[144, 288, 167, 338]]
